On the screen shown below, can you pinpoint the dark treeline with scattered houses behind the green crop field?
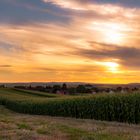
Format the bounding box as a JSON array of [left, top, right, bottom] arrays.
[[12, 83, 139, 94]]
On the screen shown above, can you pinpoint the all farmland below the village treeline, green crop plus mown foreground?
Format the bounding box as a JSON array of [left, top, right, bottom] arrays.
[[0, 88, 140, 140]]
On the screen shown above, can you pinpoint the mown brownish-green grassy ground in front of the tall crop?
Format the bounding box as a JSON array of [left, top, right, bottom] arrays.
[[0, 106, 140, 140]]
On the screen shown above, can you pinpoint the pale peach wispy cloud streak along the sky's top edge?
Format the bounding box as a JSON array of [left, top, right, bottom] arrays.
[[43, 0, 139, 17]]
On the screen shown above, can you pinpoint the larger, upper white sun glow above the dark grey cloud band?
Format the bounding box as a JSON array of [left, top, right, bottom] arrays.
[[88, 22, 127, 44]]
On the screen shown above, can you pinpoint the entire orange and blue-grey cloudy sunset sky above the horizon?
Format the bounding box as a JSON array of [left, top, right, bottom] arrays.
[[0, 0, 140, 83]]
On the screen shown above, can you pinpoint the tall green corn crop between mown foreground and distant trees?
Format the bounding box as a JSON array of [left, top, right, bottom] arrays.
[[0, 88, 140, 123]]
